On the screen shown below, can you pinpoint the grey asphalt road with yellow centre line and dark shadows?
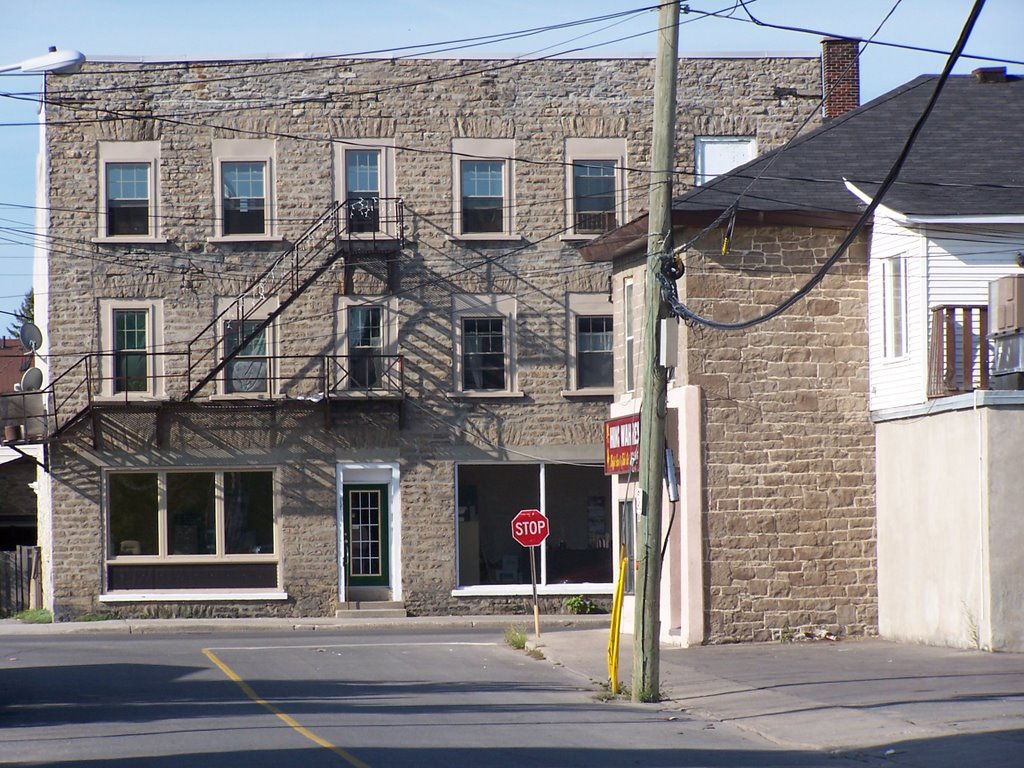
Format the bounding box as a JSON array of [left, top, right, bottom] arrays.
[[0, 629, 888, 768]]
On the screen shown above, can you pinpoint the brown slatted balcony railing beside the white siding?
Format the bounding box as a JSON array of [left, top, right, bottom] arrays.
[[928, 304, 989, 397]]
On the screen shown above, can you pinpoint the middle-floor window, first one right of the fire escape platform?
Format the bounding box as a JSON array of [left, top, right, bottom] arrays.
[[453, 294, 515, 394]]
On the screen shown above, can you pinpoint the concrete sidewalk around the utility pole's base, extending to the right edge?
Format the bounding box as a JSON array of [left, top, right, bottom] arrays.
[[527, 627, 1024, 768]]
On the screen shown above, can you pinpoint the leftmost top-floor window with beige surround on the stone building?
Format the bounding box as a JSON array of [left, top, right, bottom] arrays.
[[97, 141, 160, 241]]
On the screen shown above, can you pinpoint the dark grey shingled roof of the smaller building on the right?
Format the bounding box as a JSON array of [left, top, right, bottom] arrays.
[[581, 71, 1024, 260]]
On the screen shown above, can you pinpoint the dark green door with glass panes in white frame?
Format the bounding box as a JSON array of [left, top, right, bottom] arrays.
[[345, 484, 389, 587]]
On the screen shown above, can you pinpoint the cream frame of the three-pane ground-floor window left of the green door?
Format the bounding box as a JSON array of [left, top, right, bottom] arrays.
[[102, 466, 282, 573]]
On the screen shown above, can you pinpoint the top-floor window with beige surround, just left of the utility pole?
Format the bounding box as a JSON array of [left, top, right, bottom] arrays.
[[565, 138, 626, 237]]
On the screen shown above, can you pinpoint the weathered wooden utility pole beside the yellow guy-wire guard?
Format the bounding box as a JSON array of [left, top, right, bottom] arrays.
[[633, 2, 679, 701]]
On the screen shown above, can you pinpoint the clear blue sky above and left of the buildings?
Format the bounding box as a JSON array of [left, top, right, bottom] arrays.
[[0, 0, 1024, 325]]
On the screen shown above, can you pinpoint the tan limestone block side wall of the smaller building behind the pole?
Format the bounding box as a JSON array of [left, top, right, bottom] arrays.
[[684, 226, 878, 641]]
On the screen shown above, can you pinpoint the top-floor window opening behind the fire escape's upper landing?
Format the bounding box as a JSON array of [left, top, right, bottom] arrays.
[[335, 138, 397, 234]]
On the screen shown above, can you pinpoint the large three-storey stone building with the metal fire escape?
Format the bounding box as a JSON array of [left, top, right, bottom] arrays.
[[36, 48, 839, 622]]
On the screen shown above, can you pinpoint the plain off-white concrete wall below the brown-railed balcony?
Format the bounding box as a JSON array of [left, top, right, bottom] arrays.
[[877, 405, 1024, 651]]
